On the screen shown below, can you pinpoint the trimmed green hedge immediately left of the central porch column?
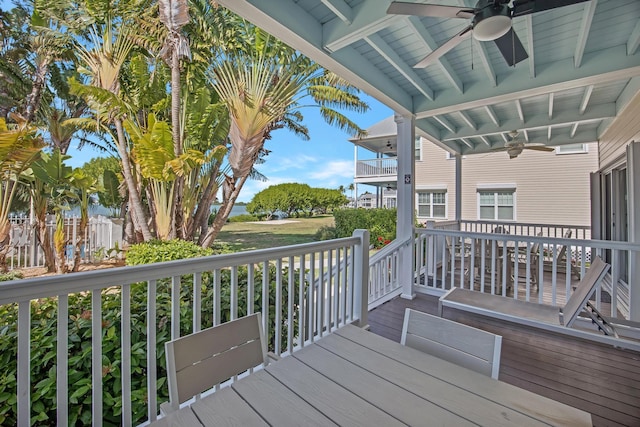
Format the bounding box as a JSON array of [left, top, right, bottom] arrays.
[[333, 208, 397, 246]]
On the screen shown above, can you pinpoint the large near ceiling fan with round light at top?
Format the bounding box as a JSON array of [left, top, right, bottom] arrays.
[[387, 0, 587, 68]]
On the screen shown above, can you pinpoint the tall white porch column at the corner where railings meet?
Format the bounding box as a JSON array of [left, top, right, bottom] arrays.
[[394, 114, 415, 299]]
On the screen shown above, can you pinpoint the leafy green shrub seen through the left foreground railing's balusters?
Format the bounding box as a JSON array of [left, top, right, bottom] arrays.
[[0, 241, 300, 426]]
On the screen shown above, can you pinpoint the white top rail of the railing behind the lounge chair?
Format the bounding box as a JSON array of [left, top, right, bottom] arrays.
[[414, 228, 640, 251]]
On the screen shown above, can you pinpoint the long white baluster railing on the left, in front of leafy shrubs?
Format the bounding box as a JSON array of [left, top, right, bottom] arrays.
[[0, 230, 369, 426]]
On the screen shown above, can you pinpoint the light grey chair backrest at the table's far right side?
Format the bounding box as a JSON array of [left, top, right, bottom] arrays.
[[400, 308, 502, 379]]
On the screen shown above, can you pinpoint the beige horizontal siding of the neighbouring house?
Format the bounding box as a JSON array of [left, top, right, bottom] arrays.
[[416, 140, 598, 225]]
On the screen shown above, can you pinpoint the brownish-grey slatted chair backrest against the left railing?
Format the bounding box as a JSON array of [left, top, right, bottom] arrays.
[[165, 313, 269, 409]]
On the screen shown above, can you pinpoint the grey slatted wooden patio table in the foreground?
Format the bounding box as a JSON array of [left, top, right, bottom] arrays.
[[152, 325, 592, 426]]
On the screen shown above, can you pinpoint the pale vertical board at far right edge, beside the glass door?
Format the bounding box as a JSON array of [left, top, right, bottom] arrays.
[[627, 142, 640, 322]]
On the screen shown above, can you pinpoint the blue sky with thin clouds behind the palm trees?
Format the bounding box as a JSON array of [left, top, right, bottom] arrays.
[[68, 94, 393, 202]]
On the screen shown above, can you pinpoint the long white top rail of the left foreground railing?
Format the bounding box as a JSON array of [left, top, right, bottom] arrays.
[[0, 237, 360, 305]]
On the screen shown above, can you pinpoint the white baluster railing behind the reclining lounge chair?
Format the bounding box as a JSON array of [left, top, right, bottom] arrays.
[[414, 228, 640, 318]]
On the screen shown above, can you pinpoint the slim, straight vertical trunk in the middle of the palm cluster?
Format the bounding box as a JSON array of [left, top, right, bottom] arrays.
[[171, 48, 184, 239]]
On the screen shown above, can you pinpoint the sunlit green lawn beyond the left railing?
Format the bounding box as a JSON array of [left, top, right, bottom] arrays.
[[216, 215, 333, 251]]
